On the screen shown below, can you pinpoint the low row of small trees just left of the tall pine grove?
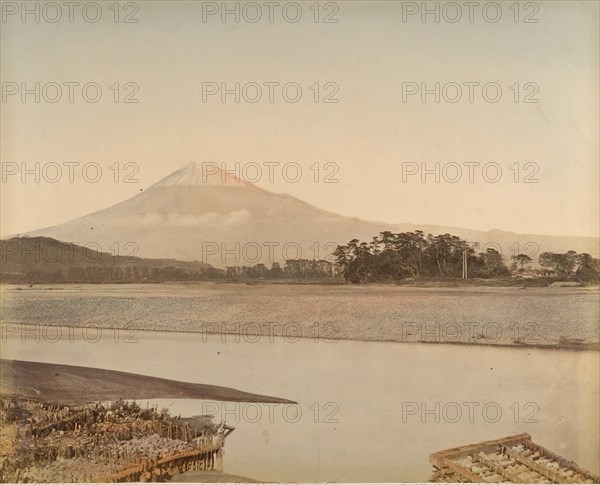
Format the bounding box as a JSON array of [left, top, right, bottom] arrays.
[[225, 259, 338, 279]]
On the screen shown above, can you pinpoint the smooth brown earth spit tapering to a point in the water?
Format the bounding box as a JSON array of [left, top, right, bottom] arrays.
[[0, 359, 295, 404]]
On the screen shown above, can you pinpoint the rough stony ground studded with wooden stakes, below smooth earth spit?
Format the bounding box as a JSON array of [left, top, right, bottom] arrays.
[[0, 397, 234, 483]]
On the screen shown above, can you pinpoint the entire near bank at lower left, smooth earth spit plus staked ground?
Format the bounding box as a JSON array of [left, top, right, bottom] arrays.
[[0, 359, 296, 482]]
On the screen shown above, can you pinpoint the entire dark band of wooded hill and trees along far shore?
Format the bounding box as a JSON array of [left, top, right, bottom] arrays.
[[0, 231, 600, 284]]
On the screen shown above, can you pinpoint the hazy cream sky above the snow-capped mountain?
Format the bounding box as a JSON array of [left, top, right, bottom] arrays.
[[1, 0, 600, 236]]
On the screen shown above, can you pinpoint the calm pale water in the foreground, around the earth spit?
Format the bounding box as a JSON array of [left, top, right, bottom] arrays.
[[2, 329, 600, 482]]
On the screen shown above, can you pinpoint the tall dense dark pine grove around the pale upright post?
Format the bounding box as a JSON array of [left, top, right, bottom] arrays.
[[333, 231, 509, 283]]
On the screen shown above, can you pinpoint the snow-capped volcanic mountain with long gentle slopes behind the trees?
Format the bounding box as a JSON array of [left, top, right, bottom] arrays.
[[29, 164, 598, 267]]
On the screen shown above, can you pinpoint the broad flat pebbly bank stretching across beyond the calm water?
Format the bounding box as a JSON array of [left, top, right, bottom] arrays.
[[0, 283, 600, 350]]
